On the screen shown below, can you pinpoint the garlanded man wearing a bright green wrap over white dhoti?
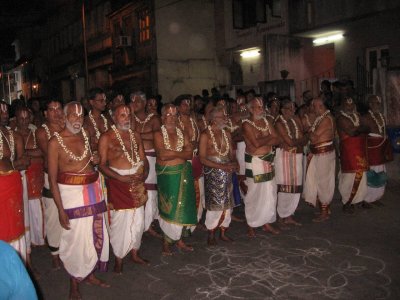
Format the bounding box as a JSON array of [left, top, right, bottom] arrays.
[[154, 104, 197, 255]]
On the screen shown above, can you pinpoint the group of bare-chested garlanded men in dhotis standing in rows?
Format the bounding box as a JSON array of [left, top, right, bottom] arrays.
[[0, 88, 388, 299]]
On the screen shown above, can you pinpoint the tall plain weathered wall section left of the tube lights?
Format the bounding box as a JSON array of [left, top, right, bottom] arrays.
[[155, 0, 227, 102]]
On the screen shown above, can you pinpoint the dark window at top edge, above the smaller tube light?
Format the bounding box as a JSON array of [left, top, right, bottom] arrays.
[[232, 0, 267, 29]]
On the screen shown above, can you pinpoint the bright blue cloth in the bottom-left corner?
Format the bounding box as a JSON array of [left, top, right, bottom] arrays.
[[0, 241, 37, 300]]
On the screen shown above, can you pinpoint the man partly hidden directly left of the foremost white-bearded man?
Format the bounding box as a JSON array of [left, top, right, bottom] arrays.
[[36, 100, 64, 269]]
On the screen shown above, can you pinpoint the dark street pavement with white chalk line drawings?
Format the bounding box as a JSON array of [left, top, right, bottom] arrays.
[[33, 181, 400, 300]]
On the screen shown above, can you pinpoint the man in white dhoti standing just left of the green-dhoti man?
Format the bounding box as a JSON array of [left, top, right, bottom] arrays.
[[129, 91, 161, 238]]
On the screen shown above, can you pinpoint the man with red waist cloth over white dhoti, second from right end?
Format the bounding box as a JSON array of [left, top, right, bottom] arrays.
[[337, 98, 369, 214]]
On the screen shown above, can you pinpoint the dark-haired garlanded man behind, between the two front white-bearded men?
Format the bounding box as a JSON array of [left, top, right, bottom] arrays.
[[84, 88, 109, 152]]
